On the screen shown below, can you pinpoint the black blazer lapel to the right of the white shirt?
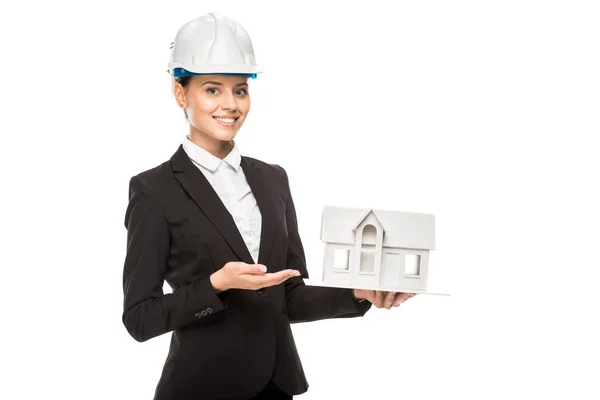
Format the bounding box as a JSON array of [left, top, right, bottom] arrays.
[[241, 156, 278, 265]]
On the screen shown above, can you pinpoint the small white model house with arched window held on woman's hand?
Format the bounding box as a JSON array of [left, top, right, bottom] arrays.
[[321, 206, 435, 293]]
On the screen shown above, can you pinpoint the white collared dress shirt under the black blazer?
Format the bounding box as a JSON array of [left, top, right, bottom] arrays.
[[183, 135, 262, 263]]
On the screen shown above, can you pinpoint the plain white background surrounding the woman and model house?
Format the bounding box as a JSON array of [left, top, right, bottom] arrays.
[[0, 0, 600, 400]]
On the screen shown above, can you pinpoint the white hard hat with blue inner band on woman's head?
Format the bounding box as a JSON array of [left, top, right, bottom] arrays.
[[169, 13, 262, 78]]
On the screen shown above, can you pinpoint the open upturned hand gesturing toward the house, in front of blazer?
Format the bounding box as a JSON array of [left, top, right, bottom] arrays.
[[210, 261, 300, 292]]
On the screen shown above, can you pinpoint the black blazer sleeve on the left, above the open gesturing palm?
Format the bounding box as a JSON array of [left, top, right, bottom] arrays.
[[122, 175, 227, 342]]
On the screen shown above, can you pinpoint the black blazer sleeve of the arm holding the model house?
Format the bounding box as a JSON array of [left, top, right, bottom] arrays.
[[278, 165, 371, 323]]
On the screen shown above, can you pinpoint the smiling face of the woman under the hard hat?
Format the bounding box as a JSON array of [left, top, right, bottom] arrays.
[[175, 74, 250, 146]]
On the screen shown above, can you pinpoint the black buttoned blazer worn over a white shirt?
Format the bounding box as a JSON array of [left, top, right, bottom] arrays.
[[123, 145, 371, 400]]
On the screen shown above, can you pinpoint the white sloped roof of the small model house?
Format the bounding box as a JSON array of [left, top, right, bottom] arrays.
[[321, 206, 435, 250]]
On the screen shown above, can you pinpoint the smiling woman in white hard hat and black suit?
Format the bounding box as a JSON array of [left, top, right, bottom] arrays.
[[123, 14, 409, 400]]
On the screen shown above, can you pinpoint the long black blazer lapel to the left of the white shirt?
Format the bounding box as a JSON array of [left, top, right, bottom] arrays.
[[171, 145, 254, 264]]
